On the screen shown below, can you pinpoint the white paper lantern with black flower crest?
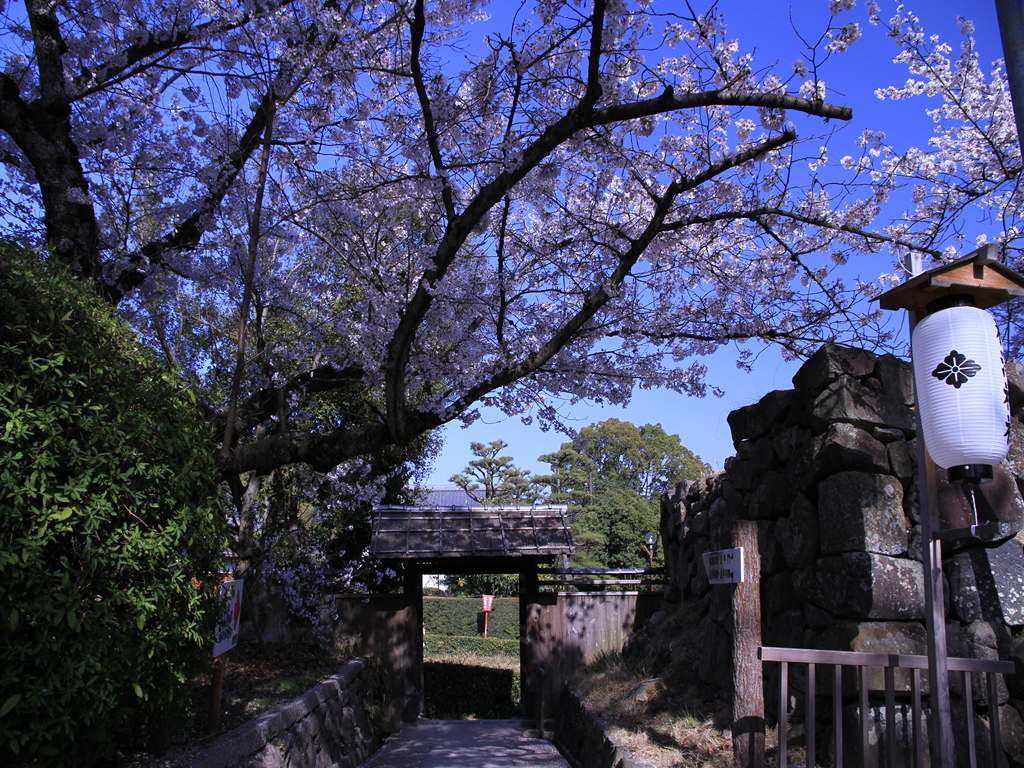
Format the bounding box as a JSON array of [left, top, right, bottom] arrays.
[[910, 306, 1010, 469]]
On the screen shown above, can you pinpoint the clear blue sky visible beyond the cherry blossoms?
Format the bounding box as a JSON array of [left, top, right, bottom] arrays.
[[428, 0, 1002, 485]]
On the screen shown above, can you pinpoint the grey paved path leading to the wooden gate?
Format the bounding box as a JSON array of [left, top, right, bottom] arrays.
[[362, 720, 569, 768]]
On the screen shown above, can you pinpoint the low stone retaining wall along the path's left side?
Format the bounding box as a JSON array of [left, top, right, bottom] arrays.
[[156, 659, 387, 768]]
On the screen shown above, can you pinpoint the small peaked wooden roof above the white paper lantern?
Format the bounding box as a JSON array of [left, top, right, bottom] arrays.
[[879, 245, 1024, 316]]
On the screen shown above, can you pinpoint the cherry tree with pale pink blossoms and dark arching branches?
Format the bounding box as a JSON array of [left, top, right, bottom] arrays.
[[0, 0, 1020, 499]]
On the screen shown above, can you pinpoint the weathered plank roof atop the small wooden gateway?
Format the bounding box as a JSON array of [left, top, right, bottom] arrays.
[[370, 505, 574, 560]]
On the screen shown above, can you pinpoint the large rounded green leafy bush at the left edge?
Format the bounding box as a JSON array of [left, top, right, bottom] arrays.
[[0, 247, 225, 765]]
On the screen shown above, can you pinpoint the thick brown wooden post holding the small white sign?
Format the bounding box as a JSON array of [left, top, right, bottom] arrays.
[[732, 520, 765, 768]]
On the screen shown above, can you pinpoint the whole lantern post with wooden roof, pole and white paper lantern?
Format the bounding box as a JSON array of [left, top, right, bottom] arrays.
[[879, 246, 1024, 768]]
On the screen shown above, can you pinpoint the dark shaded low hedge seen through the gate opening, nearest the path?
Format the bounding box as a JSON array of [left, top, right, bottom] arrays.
[[423, 662, 520, 719]]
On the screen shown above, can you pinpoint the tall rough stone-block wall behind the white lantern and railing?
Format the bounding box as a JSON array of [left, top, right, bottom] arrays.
[[633, 345, 1024, 763]]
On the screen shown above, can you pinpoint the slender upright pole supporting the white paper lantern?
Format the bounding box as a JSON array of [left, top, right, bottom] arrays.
[[908, 312, 956, 768]]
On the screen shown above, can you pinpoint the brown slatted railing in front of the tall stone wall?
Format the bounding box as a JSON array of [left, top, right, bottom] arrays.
[[759, 647, 1014, 768]]
